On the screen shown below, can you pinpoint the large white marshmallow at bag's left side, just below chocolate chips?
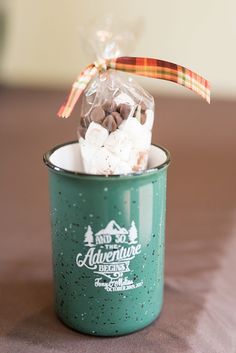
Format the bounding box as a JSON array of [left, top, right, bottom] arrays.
[[85, 121, 109, 147]]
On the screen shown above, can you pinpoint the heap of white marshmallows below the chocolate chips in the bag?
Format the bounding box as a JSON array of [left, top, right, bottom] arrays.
[[79, 110, 154, 175]]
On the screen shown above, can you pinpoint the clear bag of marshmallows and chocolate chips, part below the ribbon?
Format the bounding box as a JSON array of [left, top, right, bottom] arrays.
[[78, 70, 154, 175]]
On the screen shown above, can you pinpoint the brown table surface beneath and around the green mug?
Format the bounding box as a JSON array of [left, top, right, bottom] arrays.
[[0, 88, 236, 353]]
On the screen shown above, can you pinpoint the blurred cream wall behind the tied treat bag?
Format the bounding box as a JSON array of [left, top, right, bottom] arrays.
[[0, 0, 236, 98]]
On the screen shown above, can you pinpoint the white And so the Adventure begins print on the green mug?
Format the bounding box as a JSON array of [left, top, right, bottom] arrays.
[[76, 220, 143, 292]]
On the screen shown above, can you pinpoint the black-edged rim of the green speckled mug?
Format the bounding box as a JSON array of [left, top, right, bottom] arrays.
[[43, 140, 171, 179]]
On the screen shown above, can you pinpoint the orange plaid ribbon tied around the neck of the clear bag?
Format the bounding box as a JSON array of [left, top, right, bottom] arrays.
[[58, 57, 210, 118]]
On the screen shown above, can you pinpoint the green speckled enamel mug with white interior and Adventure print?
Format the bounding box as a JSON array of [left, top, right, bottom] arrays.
[[44, 142, 170, 336]]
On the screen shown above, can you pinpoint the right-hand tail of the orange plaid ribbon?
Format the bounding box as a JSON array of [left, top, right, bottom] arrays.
[[109, 57, 210, 103]]
